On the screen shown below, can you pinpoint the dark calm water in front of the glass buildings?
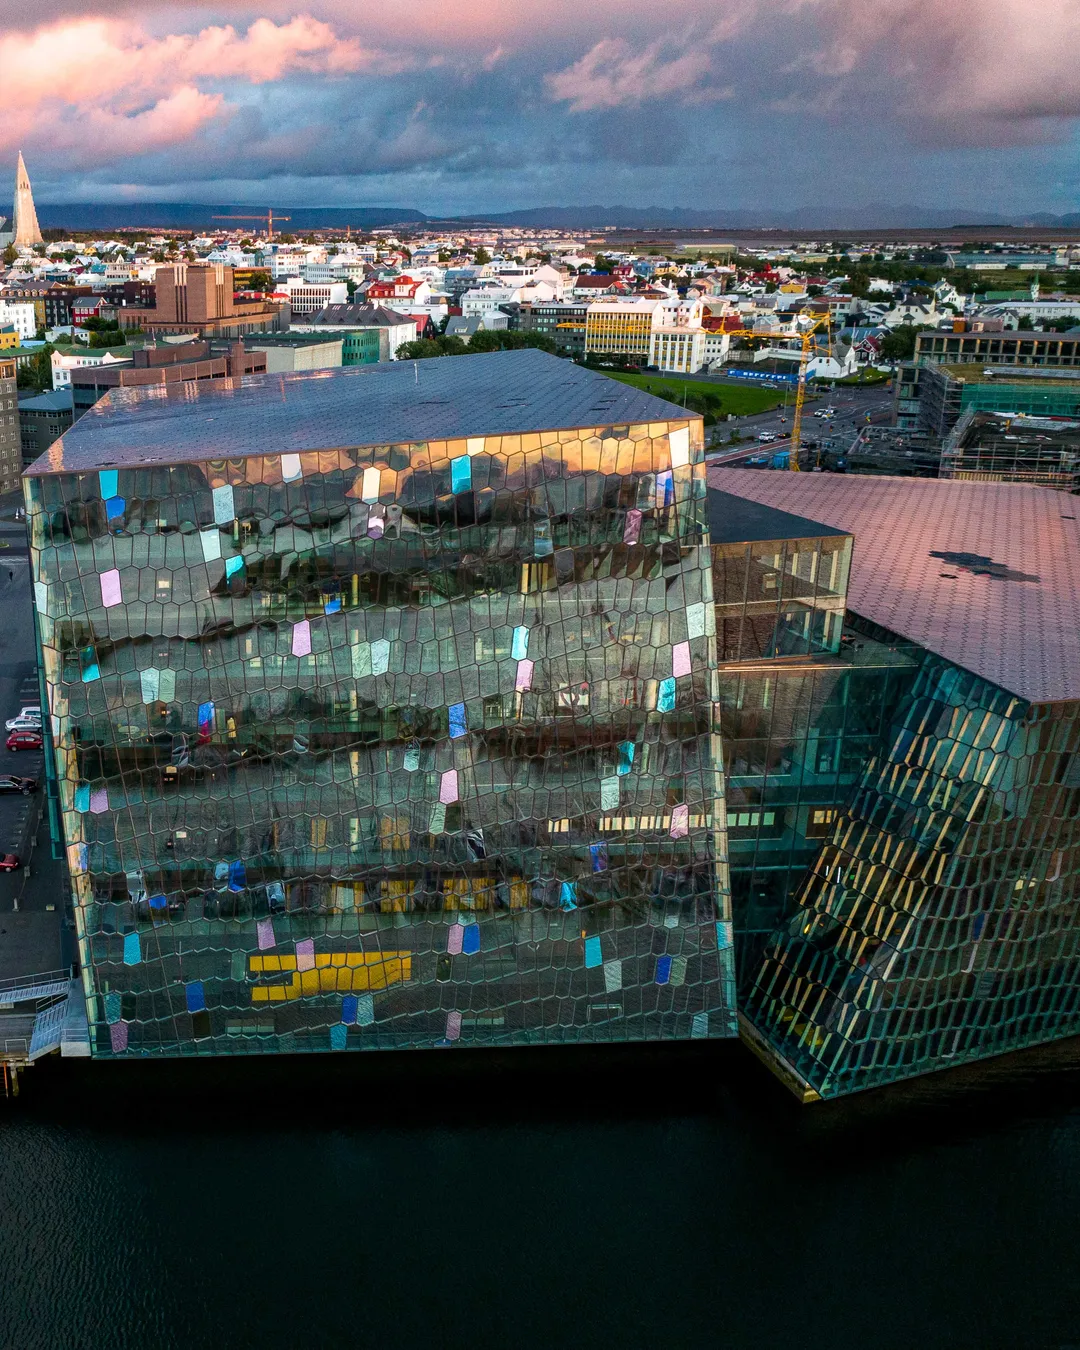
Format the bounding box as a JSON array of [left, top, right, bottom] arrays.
[[0, 1042, 1080, 1350]]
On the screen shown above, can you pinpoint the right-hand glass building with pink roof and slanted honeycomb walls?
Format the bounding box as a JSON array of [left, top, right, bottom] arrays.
[[718, 471, 1080, 1100]]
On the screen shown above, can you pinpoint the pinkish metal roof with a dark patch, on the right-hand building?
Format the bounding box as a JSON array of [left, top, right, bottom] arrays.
[[709, 467, 1080, 703]]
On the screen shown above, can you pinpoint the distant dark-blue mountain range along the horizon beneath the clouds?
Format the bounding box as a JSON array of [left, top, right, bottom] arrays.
[[29, 201, 1080, 234]]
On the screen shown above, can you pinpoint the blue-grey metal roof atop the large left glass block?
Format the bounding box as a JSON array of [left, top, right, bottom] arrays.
[[27, 348, 697, 475]]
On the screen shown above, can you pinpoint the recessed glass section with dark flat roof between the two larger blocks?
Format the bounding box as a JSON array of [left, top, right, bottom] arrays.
[[709, 487, 918, 990]]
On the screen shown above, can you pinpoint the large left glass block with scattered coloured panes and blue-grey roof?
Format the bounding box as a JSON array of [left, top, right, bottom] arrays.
[[24, 351, 736, 1057]]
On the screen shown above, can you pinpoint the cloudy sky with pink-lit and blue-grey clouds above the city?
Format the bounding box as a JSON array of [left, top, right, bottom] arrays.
[[0, 0, 1080, 219]]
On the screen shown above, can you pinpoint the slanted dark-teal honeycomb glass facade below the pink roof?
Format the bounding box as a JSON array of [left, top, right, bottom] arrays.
[[736, 629, 1080, 1098]]
